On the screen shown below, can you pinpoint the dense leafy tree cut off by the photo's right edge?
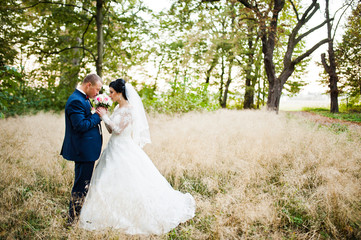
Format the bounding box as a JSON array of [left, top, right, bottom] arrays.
[[336, 3, 361, 100]]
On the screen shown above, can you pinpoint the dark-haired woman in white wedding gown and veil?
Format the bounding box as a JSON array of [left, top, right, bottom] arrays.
[[79, 79, 195, 234]]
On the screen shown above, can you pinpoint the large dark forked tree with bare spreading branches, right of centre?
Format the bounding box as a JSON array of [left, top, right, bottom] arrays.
[[238, 0, 328, 112]]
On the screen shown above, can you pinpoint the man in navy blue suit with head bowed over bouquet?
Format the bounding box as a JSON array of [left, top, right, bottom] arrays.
[[60, 74, 102, 224]]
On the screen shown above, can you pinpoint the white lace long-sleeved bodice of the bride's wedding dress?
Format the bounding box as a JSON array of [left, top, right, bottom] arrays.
[[102, 105, 133, 137]]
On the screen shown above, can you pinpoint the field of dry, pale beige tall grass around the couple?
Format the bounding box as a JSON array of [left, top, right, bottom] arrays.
[[0, 111, 361, 239]]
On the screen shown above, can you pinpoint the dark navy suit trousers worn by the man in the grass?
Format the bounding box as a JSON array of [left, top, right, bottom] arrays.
[[68, 162, 95, 222]]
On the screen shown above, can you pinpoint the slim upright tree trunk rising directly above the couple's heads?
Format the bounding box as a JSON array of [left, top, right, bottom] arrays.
[[95, 0, 104, 77]]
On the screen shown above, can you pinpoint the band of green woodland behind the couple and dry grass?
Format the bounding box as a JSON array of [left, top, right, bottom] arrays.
[[0, 0, 361, 117]]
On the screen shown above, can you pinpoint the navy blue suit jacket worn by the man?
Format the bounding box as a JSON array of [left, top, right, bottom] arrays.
[[60, 90, 103, 162]]
